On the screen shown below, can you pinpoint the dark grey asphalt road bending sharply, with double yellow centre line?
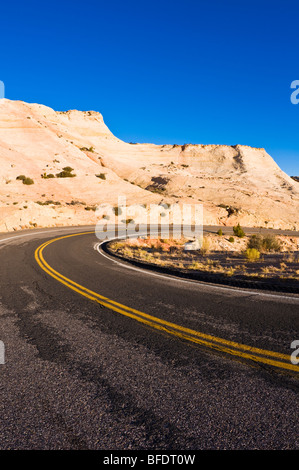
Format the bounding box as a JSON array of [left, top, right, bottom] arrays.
[[0, 227, 299, 450]]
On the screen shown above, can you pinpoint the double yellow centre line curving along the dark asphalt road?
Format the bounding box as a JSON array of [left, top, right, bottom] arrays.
[[35, 232, 299, 372]]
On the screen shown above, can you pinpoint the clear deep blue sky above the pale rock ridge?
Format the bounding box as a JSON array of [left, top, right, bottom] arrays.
[[0, 0, 299, 175]]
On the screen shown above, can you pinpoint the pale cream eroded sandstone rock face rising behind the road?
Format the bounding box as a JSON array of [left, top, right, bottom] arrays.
[[0, 99, 299, 231]]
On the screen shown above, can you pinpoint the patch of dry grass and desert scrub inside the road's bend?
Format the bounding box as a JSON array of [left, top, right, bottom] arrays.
[[109, 234, 299, 281]]
